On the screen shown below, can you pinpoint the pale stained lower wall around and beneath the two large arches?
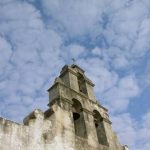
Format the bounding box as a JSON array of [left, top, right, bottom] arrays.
[[0, 104, 122, 150]]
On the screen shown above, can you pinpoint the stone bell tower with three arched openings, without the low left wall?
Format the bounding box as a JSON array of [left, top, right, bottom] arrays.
[[45, 64, 124, 150]]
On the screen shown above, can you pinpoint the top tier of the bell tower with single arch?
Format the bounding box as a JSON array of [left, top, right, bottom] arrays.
[[56, 64, 96, 101]]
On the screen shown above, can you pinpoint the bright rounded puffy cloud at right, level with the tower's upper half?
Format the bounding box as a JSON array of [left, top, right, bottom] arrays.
[[104, 75, 140, 112]]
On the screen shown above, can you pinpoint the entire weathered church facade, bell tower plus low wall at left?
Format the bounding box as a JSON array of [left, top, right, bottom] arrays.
[[0, 64, 128, 150]]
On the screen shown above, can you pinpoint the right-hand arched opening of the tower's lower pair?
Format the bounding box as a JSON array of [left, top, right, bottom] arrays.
[[93, 110, 108, 146]]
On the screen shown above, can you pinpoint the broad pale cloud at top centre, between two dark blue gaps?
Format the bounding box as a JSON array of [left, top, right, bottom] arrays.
[[41, 0, 103, 36]]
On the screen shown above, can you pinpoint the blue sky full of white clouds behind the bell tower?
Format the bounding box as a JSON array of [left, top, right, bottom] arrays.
[[0, 0, 150, 150]]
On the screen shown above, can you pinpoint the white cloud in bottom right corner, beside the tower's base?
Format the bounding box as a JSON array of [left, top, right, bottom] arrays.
[[112, 111, 150, 150]]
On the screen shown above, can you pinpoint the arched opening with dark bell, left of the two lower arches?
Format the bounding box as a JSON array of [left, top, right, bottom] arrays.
[[72, 99, 87, 138]]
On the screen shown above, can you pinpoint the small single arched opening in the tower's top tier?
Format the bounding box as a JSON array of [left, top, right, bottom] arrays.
[[77, 73, 87, 94]]
